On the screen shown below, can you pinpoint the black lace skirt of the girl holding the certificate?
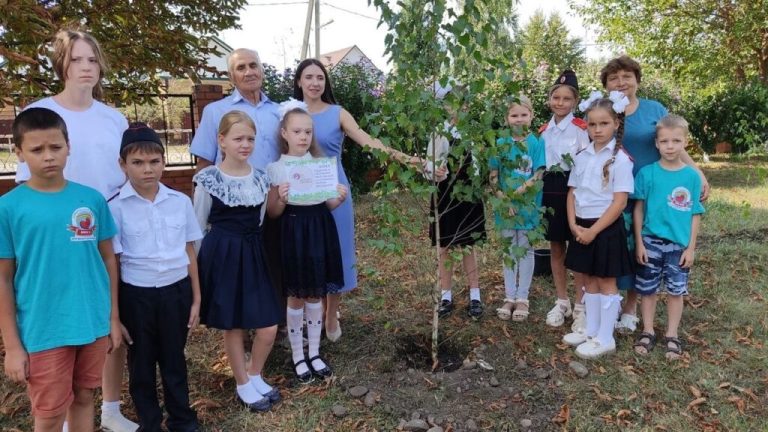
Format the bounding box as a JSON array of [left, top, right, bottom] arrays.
[[280, 203, 344, 298]]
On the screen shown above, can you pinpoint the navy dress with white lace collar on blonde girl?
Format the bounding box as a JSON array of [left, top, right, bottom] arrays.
[[194, 166, 283, 330]]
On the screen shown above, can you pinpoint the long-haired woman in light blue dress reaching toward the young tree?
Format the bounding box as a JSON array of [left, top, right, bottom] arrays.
[[293, 59, 421, 342]]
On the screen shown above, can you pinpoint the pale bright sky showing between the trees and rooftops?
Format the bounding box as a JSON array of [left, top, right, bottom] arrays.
[[220, 0, 599, 71]]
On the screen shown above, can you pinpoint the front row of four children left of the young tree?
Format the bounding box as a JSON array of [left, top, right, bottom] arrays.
[[0, 101, 347, 431]]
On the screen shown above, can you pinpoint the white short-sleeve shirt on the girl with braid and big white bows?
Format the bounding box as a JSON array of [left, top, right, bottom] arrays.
[[568, 140, 635, 219]]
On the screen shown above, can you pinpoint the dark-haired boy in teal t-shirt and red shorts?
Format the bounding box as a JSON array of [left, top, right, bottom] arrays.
[[0, 108, 122, 432]]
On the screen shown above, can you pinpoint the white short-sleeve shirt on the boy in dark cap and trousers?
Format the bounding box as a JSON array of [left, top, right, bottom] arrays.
[[109, 182, 203, 287]]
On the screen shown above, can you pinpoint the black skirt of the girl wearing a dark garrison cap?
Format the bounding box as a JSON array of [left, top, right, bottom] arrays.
[[541, 171, 573, 242]]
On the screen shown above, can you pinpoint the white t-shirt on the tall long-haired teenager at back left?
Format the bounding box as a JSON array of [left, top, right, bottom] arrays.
[[16, 97, 128, 200]]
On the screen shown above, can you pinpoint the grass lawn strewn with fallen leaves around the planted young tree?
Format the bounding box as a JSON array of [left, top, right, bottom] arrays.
[[0, 154, 768, 431]]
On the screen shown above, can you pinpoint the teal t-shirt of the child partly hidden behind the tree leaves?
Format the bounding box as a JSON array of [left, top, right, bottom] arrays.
[[489, 134, 547, 230]]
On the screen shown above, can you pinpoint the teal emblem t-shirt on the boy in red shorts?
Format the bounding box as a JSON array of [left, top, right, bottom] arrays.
[[0, 182, 116, 353]]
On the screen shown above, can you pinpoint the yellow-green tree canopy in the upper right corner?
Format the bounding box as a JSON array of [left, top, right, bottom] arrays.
[[573, 0, 768, 88]]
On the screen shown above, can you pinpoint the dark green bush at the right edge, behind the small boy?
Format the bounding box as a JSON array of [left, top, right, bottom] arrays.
[[681, 80, 768, 153]]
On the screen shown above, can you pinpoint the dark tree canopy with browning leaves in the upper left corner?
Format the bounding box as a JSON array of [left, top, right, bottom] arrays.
[[0, 0, 246, 104]]
